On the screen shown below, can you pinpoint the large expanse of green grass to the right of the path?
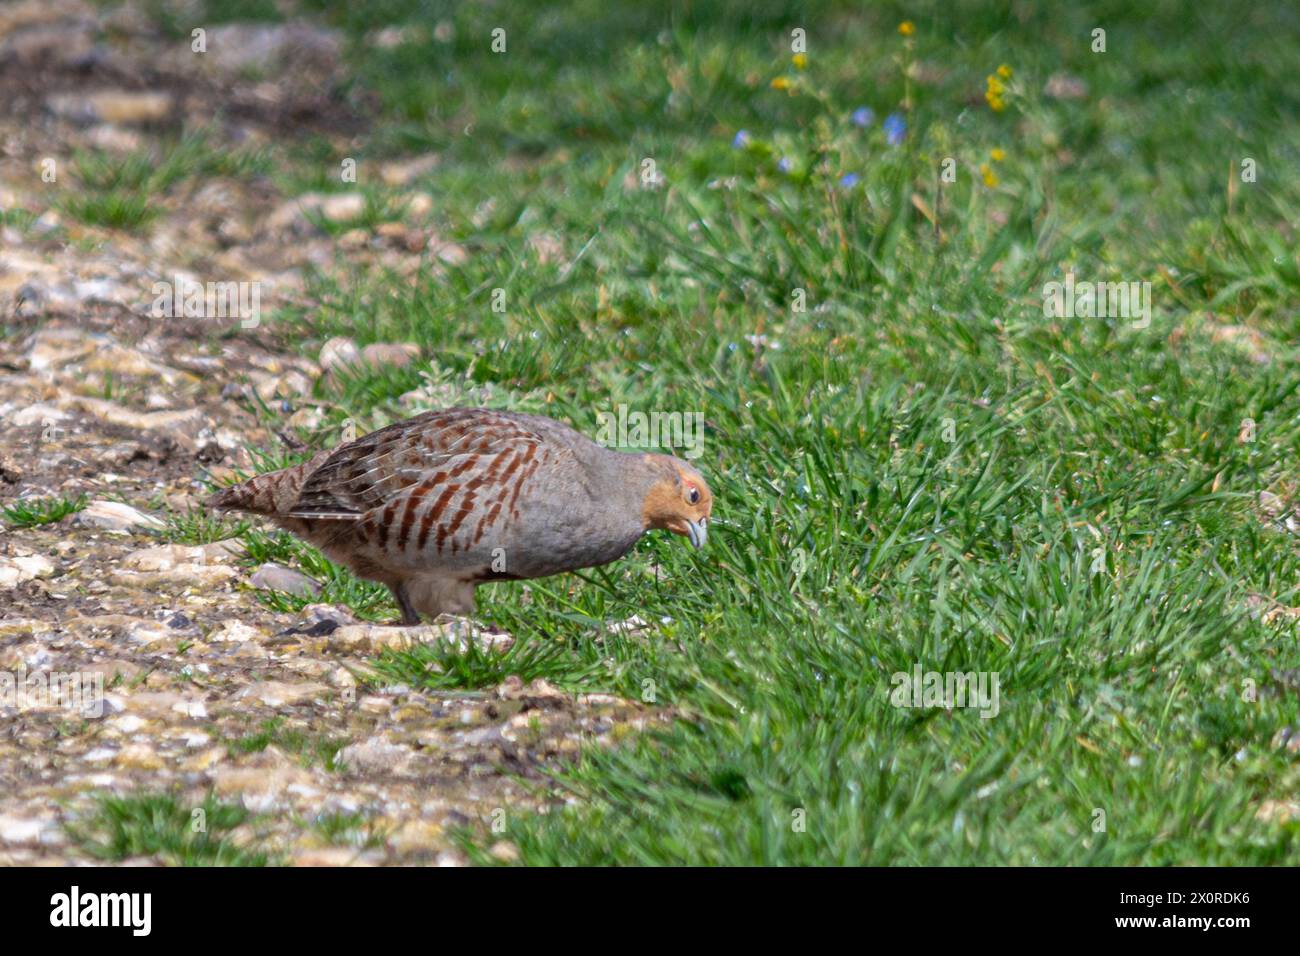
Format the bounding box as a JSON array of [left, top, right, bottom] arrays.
[[172, 0, 1300, 865]]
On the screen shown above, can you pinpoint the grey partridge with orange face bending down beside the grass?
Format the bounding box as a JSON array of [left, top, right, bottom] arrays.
[[205, 407, 714, 626]]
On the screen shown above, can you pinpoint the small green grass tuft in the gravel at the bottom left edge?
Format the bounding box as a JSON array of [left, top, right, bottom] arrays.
[[66, 793, 270, 866]]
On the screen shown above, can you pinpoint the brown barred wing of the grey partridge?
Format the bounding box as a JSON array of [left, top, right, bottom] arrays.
[[289, 408, 554, 557]]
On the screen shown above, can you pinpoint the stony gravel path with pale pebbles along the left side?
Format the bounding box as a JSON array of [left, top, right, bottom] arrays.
[[0, 0, 663, 865]]
